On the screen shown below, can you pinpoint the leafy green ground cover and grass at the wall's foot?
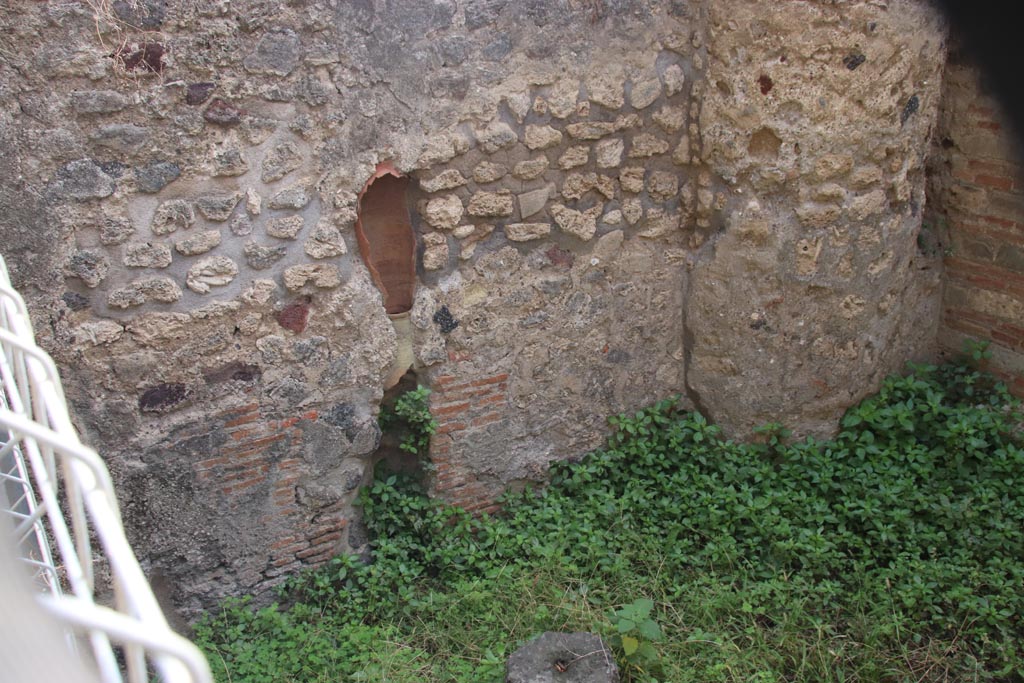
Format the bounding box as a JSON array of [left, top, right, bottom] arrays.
[[197, 352, 1024, 683]]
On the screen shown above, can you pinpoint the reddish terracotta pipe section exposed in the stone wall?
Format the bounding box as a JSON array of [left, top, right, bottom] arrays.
[[355, 162, 416, 315]]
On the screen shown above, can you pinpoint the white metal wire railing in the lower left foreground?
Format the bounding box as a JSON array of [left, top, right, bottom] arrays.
[[0, 256, 211, 683]]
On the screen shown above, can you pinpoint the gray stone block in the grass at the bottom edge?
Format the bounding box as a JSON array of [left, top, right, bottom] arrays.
[[505, 631, 618, 683]]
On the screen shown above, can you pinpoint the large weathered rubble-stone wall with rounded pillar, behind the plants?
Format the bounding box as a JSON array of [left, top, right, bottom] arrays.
[[0, 0, 945, 613]]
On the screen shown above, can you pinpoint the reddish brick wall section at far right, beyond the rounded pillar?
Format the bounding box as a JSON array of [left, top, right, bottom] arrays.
[[923, 42, 1024, 395]]
